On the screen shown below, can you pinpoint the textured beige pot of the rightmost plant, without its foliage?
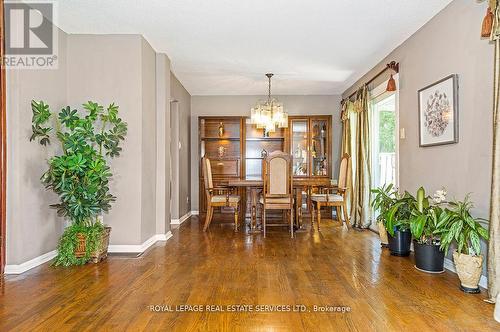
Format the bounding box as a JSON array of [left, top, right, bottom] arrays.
[[453, 251, 483, 293]]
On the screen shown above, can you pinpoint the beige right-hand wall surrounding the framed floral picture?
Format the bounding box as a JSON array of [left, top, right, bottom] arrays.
[[344, 0, 493, 222]]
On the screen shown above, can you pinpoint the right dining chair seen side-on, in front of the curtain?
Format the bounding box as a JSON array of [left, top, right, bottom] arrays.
[[311, 153, 351, 230]]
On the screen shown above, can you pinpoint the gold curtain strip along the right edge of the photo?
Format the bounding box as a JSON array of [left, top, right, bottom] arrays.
[[488, 0, 500, 305]]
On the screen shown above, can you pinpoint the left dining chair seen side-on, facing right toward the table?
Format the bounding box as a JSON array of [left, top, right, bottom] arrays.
[[202, 157, 240, 232]]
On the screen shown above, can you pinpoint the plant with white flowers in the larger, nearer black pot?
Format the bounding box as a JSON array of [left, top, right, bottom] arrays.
[[410, 187, 450, 273]]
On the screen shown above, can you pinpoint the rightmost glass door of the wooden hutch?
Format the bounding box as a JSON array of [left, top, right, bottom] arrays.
[[311, 119, 329, 176]]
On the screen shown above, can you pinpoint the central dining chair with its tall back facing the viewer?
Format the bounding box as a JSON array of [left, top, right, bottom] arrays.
[[259, 151, 293, 238]]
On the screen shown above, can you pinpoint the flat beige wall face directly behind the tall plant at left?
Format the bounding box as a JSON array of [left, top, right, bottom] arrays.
[[68, 35, 143, 244]]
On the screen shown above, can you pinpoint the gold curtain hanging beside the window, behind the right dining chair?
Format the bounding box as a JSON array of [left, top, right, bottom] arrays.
[[342, 86, 371, 228]]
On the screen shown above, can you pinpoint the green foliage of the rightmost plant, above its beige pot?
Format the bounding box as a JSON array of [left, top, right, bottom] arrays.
[[441, 195, 489, 256]]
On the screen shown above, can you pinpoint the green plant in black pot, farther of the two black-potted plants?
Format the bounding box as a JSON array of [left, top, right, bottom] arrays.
[[384, 191, 416, 256]]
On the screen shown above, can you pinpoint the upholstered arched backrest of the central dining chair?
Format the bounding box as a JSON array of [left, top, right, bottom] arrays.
[[262, 151, 293, 199]]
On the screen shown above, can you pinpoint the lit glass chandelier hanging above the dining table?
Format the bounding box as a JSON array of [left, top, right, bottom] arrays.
[[250, 74, 288, 134]]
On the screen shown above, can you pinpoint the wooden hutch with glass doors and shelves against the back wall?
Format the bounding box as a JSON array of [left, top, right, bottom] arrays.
[[198, 115, 332, 212]]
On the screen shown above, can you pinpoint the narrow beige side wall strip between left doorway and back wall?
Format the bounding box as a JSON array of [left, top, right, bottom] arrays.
[[170, 73, 191, 219]]
